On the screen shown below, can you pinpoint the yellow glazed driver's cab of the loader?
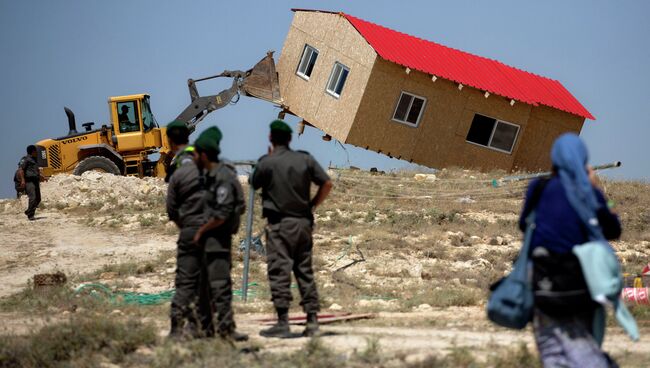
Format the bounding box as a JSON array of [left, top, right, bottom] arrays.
[[108, 94, 160, 152]]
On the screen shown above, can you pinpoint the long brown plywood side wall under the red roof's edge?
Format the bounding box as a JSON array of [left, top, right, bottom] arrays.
[[346, 58, 584, 170]]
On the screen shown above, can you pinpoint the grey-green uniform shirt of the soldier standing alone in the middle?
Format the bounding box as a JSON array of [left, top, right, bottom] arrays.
[[252, 146, 330, 218]]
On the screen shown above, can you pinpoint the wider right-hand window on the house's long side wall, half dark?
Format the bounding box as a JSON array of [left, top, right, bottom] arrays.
[[467, 114, 519, 153]]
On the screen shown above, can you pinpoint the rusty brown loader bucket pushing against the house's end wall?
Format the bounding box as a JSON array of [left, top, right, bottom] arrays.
[[242, 52, 282, 104]]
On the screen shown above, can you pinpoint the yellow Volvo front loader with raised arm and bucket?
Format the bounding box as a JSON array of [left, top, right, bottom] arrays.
[[36, 52, 281, 177]]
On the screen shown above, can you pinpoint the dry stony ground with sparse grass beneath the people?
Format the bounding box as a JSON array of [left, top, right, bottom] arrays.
[[0, 170, 650, 367]]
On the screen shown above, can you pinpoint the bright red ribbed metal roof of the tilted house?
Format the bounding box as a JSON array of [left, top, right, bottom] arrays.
[[292, 9, 595, 120]]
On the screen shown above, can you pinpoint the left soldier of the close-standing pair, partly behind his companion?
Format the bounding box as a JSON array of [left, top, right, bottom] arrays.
[[167, 121, 213, 337]]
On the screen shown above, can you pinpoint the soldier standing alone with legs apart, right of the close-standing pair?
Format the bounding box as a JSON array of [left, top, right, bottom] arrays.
[[252, 120, 332, 337]]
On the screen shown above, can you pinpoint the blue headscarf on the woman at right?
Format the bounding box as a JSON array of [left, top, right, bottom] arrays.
[[551, 133, 604, 240]]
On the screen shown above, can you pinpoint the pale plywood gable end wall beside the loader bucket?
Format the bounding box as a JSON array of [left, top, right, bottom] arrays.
[[277, 11, 376, 142]]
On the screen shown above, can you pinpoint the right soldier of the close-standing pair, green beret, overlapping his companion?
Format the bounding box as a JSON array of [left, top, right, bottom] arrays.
[[194, 127, 248, 341]]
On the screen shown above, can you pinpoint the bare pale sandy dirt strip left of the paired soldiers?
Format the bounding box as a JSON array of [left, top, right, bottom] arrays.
[[0, 211, 176, 297]]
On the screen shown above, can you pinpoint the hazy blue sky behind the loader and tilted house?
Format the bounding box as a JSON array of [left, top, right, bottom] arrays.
[[0, 0, 650, 197]]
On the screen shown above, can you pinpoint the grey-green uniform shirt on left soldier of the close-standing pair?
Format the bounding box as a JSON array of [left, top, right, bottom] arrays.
[[167, 161, 205, 227]]
